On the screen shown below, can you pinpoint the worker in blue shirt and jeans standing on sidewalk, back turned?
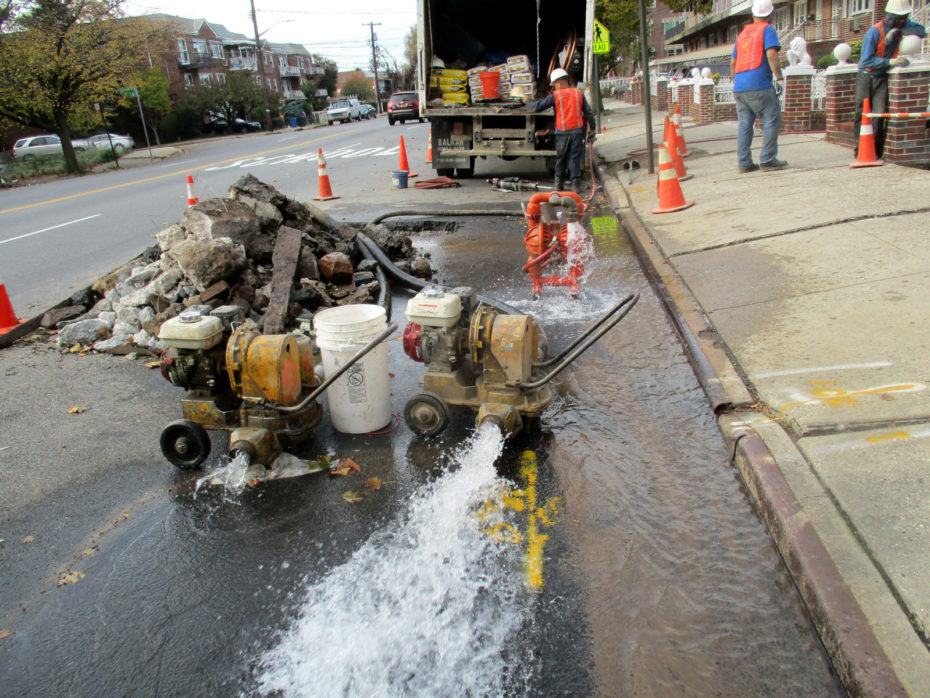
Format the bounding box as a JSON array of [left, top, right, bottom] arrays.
[[730, 0, 788, 174]]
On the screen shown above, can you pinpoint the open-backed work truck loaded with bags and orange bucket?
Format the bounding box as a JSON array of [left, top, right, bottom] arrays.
[[417, 0, 596, 177]]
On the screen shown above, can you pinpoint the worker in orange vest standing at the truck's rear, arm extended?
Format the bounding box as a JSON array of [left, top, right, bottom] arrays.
[[524, 68, 597, 194]]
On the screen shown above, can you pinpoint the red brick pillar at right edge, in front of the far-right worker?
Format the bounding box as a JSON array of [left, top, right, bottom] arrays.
[[884, 67, 930, 166]]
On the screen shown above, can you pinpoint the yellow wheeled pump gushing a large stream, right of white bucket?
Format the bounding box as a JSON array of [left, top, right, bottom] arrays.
[[403, 287, 639, 436]]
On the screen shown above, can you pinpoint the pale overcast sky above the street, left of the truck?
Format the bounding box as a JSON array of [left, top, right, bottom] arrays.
[[123, 0, 417, 70]]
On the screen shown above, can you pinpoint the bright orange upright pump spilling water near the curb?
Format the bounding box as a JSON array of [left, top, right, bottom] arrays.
[[523, 191, 587, 299]]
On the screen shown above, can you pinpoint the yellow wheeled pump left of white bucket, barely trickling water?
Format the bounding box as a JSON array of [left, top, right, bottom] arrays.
[[158, 306, 397, 468]]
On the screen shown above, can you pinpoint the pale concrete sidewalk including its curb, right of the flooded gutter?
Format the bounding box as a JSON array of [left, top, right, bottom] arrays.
[[595, 96, 930, 696]]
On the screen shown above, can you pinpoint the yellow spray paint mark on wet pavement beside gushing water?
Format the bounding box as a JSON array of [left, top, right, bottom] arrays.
[[476, 451, 559, 589]]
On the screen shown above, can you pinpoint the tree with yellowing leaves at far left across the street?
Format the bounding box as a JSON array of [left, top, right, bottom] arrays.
[[0, 0, 170, 172]]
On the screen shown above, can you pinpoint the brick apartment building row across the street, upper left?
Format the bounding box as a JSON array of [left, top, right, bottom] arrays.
[[146, 14, 323, 100]]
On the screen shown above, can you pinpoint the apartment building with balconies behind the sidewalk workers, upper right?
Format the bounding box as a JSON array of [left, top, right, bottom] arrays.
[[650, 0, 930, 75]]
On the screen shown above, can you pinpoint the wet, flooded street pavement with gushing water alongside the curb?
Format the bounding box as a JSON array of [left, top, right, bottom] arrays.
[[0, 195, 842, 696]]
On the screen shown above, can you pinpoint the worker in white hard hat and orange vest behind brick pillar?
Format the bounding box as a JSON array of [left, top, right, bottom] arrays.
[[854, 0, 926, 158]]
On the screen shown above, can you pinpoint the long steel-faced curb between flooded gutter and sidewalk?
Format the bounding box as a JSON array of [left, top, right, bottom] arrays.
[[595, 159, 907, 696]]
